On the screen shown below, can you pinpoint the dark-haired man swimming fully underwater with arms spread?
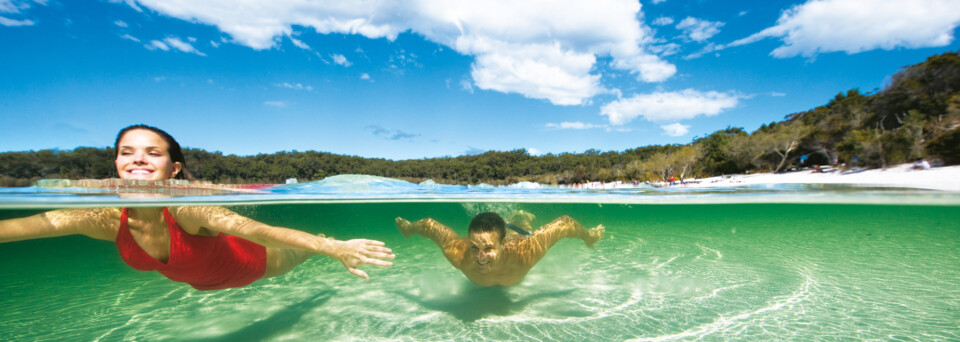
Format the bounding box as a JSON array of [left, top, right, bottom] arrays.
[[396, 211, 604, 286]]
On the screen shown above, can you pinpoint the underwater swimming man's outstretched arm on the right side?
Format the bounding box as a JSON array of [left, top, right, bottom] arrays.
[[518, 215, 604, 266]]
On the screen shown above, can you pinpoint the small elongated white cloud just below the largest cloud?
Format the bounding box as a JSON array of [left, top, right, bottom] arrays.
[[600, 89, 740, 125]]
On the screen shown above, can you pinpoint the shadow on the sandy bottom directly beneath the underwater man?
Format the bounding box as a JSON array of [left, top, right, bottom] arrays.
[[395, 284, 574, 322]]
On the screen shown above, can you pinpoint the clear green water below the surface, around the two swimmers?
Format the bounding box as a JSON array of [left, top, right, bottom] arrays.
[[0, 203, 960, 341]]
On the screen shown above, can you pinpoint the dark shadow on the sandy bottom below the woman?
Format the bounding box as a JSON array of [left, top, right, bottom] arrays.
[[192, 290, 337, 342]]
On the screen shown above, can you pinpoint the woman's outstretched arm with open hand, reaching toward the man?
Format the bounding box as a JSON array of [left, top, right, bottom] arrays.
[[170, 207, 394, 278]]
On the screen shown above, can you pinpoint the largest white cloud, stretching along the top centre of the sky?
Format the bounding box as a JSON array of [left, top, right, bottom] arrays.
[[118, 0, 676, 105]]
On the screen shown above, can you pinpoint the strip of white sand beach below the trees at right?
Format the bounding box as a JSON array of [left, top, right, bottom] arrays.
[[687, 163, 960, 191]]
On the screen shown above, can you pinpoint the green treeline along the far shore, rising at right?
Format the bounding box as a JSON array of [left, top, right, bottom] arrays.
[[0, 52, 960, 186]]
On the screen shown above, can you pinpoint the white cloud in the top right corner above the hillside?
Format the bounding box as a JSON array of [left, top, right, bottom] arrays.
[[727, 0, 960, 58]]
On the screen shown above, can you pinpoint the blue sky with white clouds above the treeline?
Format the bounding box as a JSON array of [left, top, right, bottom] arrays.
[[0, 0, 960, 160]]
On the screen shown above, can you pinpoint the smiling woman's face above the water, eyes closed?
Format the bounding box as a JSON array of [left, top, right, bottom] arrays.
[[116, 129, 182, 180]]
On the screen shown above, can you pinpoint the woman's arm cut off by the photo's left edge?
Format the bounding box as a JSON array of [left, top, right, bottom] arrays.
[[0, 209, 120, 243]]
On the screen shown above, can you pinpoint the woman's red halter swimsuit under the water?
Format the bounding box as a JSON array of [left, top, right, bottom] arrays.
[[117, 208, 267, 290]]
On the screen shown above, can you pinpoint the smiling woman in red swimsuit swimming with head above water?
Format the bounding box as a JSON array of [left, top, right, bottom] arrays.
[[0, 125, 394, 290]]
